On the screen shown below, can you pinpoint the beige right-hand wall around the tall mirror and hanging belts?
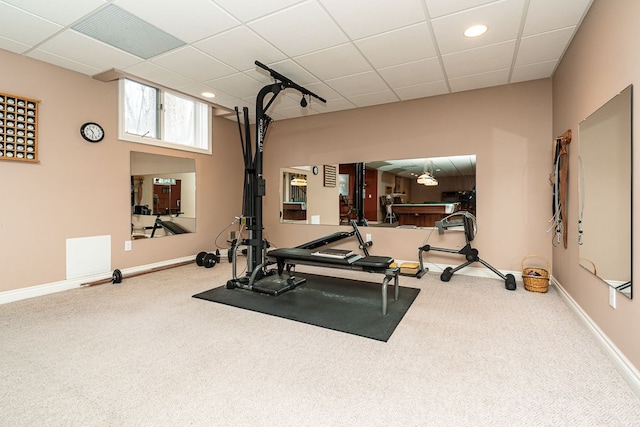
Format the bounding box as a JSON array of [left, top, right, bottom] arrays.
[[553, 0, 640, 369]]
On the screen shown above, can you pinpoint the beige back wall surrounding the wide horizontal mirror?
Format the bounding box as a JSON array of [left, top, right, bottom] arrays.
[[264, 80, 552, 272]]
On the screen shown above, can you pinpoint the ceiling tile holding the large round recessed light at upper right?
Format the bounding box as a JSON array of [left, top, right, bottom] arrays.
[[432, 0, 524, 55]]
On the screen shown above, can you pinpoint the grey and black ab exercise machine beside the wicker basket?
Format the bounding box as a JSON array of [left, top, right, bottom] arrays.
[[418, 211, 516, 291]]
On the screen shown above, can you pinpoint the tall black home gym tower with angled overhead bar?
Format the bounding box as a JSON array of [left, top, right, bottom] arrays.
[[227, 61, 327, 295]]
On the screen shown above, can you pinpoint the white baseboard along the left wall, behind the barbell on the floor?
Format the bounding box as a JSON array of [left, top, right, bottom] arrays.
[[0, 255, 195, 305]]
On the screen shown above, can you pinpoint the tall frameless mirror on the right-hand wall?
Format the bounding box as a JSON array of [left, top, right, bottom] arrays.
[[578, 86, 633, 298]]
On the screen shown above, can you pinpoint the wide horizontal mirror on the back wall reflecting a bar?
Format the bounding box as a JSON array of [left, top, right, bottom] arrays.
[[280, 155, 476, 228]]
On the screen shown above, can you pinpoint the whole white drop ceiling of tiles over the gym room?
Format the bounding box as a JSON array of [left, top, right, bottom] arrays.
[[0, 0, 592, 120]]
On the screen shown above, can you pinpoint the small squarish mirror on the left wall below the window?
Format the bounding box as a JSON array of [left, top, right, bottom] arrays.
[[130, 151, 196, 240]]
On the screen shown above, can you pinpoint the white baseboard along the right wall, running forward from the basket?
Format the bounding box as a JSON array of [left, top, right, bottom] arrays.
[[551, 276, 640, 397]]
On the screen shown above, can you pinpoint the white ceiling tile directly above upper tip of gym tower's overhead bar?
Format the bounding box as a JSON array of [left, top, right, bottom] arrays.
[[194, 26, 286, 71]]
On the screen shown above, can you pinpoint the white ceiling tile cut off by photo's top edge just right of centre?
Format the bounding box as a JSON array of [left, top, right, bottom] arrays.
[[320, 0, 426, 40]]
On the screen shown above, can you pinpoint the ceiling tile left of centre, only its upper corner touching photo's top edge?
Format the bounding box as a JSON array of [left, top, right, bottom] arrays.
[[248, 1, 348, 57]]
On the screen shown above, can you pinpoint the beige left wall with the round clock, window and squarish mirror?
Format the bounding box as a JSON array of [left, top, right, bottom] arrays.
[[0, 50, 243, 292]]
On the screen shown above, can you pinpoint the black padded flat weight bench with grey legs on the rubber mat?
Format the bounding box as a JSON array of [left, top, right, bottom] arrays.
[[267, 248, 400, 315]]
